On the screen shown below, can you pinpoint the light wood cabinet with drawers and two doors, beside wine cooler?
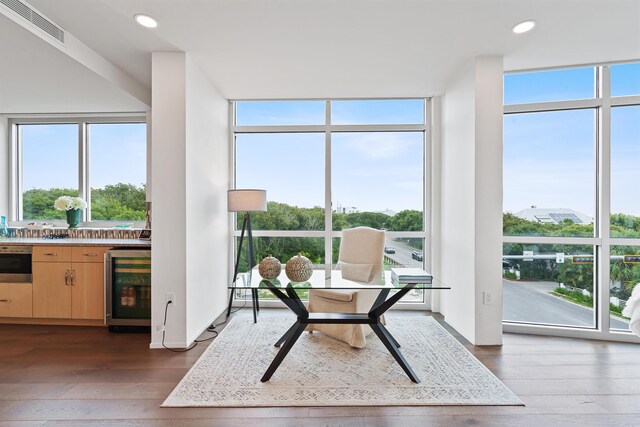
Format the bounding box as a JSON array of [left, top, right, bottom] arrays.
[[32, 246, 107, 319]]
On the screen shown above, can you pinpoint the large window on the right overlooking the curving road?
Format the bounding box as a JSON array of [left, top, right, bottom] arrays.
[[502, 64, 640, 339]]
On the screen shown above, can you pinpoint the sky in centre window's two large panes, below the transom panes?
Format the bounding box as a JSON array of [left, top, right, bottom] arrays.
[[236, 132, 423, 212]]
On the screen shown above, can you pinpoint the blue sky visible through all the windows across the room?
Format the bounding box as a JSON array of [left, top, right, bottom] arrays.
[[17, 63, 640, 216]]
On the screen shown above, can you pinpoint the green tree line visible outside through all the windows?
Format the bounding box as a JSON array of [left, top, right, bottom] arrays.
[[23, 187, 640, 300]]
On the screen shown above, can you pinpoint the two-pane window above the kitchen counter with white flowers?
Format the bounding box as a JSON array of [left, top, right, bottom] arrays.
[[10, 118, 147, 223]]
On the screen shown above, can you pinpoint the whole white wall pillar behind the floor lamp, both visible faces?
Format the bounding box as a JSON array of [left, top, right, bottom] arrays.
[[151, 53, 229, 348]]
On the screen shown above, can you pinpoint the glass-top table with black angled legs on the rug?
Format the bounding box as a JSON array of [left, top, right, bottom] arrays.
[[229, 264, 451, 383]]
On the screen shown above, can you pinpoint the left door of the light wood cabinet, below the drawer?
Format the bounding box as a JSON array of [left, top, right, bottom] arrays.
[[33, 262, 71, 319]]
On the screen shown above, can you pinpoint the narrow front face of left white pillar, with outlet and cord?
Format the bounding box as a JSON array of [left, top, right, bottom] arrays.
[[151, 53, 187, 347]]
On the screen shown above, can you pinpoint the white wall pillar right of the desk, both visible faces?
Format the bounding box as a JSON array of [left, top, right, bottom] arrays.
[[436, 57, 503, 345]]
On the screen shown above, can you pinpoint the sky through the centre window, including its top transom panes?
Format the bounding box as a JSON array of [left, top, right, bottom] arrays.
[[236, 99, 424, 212]]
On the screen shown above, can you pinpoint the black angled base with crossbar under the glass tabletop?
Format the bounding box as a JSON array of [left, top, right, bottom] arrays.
[[260, 280, 420, 383]]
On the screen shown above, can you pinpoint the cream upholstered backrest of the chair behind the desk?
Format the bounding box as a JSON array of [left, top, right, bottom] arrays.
[[338, 227, 385, 282]]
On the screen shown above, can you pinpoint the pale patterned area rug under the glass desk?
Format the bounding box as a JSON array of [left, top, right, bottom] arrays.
[[162, 316, 522, 407]]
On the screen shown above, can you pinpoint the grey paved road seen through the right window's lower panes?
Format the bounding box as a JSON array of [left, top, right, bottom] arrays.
[[502, 280, 629, 330]]
